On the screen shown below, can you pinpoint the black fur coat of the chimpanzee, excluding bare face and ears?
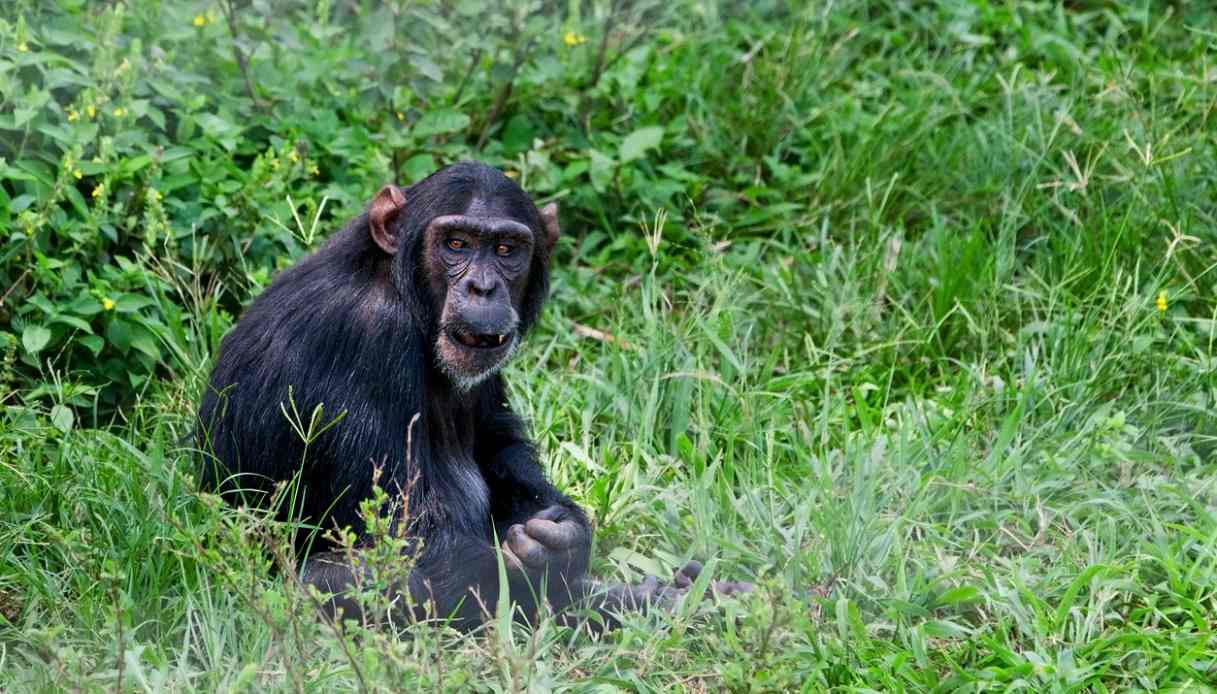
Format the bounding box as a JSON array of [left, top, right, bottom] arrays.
[[198, 162, 591, 626]]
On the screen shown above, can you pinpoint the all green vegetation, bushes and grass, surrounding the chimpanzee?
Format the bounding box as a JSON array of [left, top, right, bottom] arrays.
[[0, 0, 1217, 692]]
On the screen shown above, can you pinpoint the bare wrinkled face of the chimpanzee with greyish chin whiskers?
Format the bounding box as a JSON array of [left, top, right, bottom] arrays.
[[422, 200, 537, 390]]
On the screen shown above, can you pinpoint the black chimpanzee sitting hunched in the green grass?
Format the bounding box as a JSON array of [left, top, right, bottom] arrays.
[[198, 162, 746, 628]]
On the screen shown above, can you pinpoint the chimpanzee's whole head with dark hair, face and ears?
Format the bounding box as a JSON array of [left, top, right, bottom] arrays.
[[368, 162, 559, 390]]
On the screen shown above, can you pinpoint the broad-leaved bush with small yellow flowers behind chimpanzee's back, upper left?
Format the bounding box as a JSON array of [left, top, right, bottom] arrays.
[[0, 1, 710, 416]]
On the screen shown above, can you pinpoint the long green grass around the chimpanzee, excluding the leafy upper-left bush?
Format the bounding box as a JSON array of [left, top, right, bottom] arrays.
[[0, 0, 1217, 692]]
